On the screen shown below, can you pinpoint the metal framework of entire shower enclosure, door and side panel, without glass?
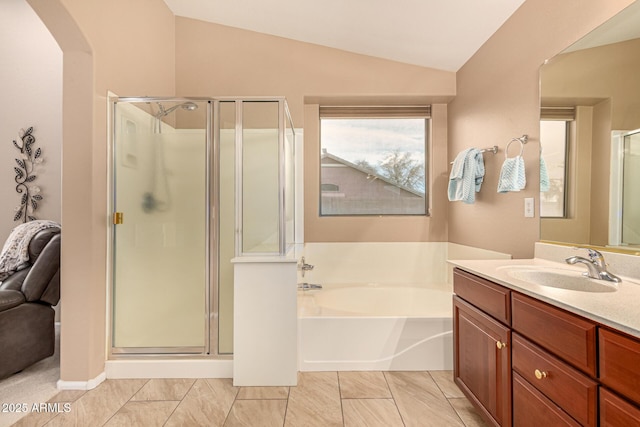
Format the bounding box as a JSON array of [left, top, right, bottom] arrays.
[[107, 93, 295, 359]]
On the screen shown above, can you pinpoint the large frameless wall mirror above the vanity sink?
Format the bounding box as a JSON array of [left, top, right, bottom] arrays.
[[540, 1, 640, 252]]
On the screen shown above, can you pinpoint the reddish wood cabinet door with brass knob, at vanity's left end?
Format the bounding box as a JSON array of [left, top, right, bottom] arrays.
[[453, 296, 511, 426]]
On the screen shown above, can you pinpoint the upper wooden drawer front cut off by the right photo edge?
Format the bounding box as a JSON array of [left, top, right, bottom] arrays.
[[599, 328, 640, 404]]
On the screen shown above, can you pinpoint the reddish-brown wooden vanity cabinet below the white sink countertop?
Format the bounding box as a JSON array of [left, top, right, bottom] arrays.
[[453, 268, 640, 427]]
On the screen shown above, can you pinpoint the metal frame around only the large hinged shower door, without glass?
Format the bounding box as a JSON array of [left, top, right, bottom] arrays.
[[107, 93, 219, 359]]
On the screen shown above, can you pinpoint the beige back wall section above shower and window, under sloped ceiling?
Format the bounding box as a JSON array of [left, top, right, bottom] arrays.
[[176, 17, 455, 127]]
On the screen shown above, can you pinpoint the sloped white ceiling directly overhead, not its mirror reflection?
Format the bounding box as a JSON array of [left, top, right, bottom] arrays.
[[164, 0, 524, 71]]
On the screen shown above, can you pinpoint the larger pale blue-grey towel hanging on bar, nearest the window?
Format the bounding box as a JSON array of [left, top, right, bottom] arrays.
[[448, 148, 484, 203]]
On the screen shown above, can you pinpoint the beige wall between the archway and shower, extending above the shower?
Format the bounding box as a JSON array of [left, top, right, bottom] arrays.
[[28, 0, 175, 381]]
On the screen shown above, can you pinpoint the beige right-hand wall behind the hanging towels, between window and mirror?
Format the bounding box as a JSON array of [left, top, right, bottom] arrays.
[[448, 0, 632, 258]]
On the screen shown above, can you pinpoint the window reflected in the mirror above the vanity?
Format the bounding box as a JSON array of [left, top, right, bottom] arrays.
[[540, 108, 573, 218]]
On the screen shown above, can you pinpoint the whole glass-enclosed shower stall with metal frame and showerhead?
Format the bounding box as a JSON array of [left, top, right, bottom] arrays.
[[109, 96, 295, 359]]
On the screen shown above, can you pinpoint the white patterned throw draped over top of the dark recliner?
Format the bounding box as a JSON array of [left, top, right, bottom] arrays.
[[0, 220, 60, 282]]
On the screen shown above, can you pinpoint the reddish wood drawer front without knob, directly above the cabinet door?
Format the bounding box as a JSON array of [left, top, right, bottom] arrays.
[[453, 268, 511, 325]]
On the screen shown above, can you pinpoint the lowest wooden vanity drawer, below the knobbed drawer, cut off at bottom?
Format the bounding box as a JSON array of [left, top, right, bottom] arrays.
[[513, 372, 580, 427]]
